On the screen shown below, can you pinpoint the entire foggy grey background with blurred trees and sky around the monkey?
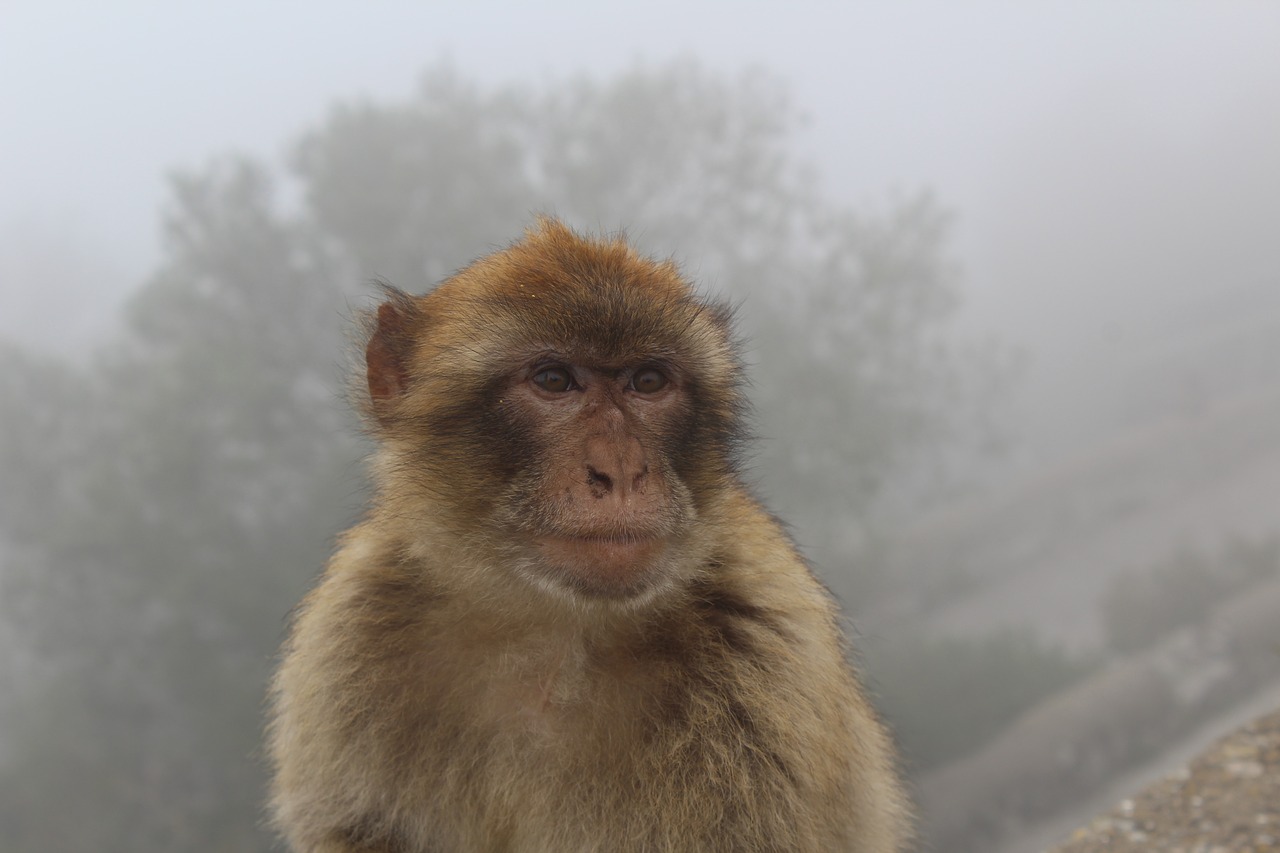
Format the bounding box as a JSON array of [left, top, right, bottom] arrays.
[[0, 0, 1280, 850]]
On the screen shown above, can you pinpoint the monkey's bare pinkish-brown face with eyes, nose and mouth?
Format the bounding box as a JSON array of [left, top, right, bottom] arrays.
[[493, 352, 698, 598]]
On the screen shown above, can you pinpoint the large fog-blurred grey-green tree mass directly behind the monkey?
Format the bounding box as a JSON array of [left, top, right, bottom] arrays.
[[0, 63, 1018, 853]]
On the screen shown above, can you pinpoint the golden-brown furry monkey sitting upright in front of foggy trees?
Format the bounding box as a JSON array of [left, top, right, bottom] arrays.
[[268, 218, 914, 853]]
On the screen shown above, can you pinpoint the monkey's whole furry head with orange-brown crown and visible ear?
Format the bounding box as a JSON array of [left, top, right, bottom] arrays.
[[365, 220, 742, 599]]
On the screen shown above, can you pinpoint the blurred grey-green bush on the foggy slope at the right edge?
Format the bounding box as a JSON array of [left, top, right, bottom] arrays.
[[1101, 538, 1280, 654]]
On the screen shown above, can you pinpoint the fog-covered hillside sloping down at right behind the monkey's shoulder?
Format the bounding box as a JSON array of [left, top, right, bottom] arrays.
[[896, 281, 1280, 853]]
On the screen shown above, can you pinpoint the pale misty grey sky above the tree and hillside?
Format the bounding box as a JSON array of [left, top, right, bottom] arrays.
[[0, 0, 1280, 381]]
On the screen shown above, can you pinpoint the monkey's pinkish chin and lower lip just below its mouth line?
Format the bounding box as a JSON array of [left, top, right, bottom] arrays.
[[536, 537, 666, 598]]
